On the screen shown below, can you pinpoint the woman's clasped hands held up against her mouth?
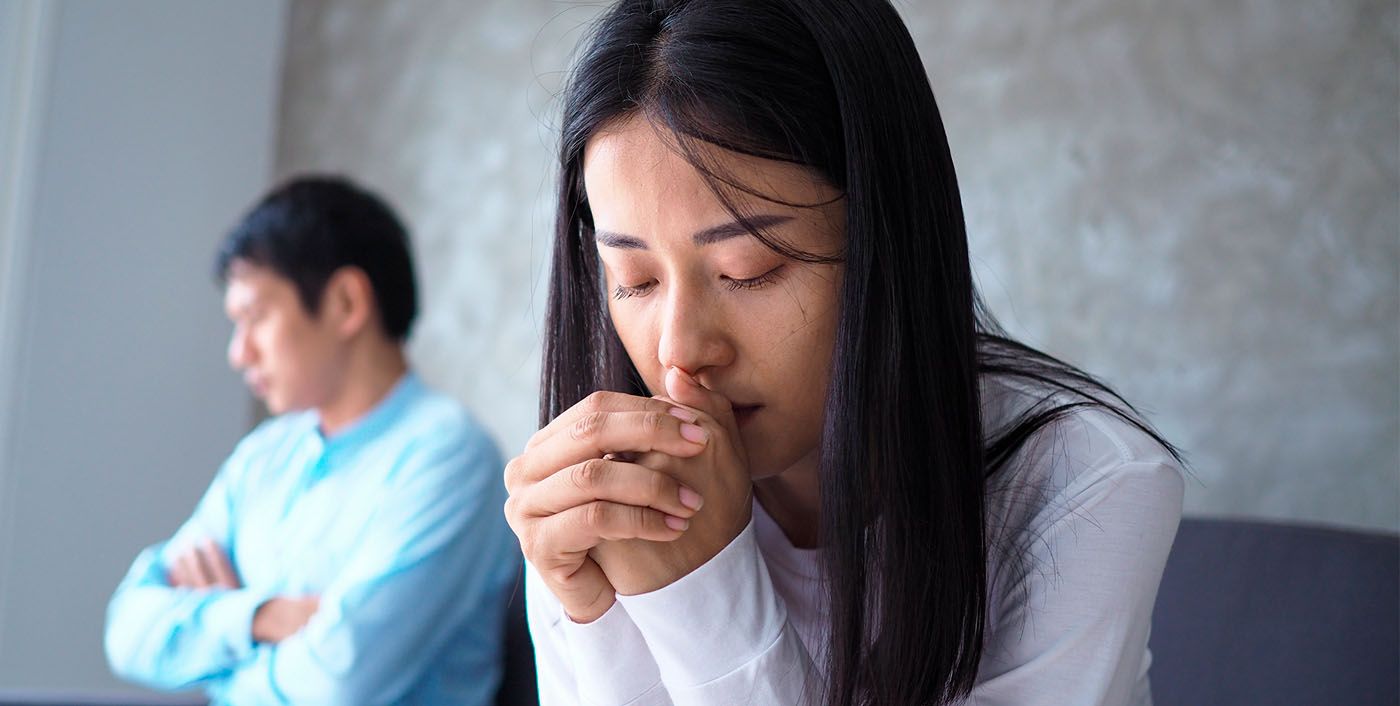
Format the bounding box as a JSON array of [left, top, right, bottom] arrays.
[[505, 367, 753, 623]]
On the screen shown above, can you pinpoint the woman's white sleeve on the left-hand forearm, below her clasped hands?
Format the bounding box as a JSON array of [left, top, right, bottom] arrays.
[[525, 563, 672, 706]]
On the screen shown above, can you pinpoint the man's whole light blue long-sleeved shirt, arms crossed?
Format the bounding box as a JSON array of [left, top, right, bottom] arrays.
[[105, 374, 519, 706]]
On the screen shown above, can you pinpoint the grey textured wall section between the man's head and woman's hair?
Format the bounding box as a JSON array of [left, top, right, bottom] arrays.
[[277, 0, 576, 467]]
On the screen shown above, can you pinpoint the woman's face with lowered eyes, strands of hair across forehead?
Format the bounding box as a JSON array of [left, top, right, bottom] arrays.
[[584, 119, 844, 479]]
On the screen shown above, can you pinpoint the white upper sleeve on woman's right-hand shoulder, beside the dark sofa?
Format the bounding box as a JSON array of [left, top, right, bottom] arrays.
[[966, 462, 1184, 706]]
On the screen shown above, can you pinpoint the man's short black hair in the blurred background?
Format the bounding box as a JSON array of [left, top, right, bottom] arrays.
[[214, 175, 419, 342]]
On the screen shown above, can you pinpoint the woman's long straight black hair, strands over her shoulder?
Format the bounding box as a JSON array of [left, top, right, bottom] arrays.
[[540, 0, 1175, 706]]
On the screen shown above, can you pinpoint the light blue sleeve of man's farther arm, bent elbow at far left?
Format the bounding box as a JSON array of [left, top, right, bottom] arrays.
[[104, 450, 266, 689]]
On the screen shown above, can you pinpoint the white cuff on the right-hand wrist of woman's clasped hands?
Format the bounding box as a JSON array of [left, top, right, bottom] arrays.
[[617, 520, 787, 689]]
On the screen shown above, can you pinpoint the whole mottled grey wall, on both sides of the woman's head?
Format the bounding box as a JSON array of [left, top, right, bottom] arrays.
[[277, 0, 1400, 530]]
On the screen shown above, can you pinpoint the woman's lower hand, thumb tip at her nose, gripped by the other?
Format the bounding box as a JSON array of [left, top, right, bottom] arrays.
[[589, 368, 753, 595]]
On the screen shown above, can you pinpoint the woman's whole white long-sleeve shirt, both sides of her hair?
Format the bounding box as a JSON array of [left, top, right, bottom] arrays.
[[526, 382, 1184, 706]]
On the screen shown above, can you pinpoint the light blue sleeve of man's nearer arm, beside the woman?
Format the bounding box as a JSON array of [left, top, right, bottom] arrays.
[[218, 425, 519, 706]]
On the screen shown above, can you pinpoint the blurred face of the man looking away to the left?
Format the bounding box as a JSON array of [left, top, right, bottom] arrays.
[[224, 261, 346, 415]]
